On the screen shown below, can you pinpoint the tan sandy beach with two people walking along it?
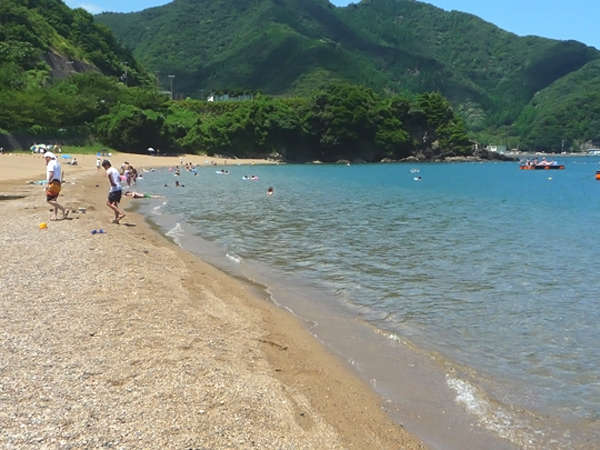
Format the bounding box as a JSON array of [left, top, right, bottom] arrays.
[[0, 154, 424, 449]]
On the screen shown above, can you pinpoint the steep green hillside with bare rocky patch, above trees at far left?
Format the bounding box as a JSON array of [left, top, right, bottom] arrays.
[[0, 0, 147, 89]]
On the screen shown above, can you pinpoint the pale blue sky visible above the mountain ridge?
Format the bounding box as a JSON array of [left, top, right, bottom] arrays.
[[65, 0, 600, 50]]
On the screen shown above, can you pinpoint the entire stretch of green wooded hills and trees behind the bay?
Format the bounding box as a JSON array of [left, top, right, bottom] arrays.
[[0, 0, 600, 154]]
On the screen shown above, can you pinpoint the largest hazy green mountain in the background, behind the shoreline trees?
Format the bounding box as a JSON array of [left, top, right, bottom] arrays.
[[96, 0, 600, 149]]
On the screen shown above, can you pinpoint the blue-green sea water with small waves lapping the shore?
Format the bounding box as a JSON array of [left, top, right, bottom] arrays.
[[136, 157, 600, 448]]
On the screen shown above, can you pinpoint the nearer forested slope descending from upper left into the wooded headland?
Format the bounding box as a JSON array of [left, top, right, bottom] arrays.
[[0, 0, 472, 162]]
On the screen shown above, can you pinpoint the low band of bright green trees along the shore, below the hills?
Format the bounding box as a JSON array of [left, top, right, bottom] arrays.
[[0, 59, 471, 162]]
